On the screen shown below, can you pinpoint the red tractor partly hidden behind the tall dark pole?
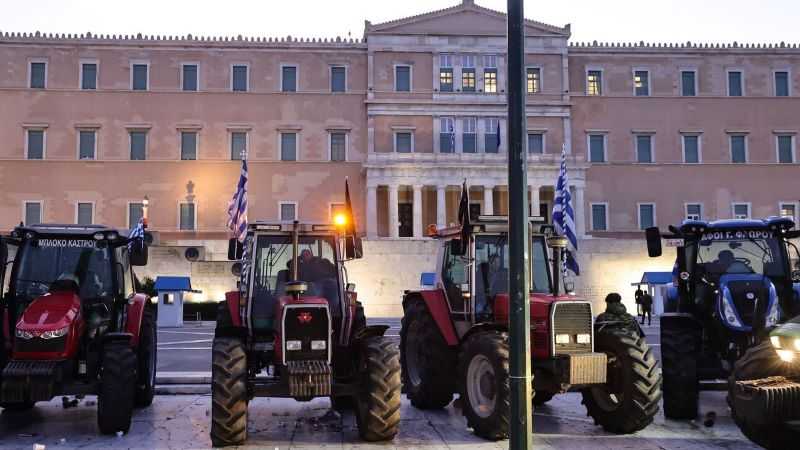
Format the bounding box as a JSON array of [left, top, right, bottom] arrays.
[[400, 216, 661, 440]]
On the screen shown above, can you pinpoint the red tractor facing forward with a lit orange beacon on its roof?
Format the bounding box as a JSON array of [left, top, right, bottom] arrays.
[[211, 218, 401, 446]]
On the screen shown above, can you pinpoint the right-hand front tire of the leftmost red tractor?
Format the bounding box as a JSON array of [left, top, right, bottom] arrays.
[[97, 342, 138, 434]]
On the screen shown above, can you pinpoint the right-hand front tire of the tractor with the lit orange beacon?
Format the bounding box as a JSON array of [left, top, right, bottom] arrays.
[[355, 336, 401, 442]]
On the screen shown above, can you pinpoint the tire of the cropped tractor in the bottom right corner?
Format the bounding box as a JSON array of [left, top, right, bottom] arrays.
[[728, 340, 800, 449]]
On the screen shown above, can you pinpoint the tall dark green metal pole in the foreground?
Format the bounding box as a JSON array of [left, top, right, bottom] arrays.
[[507, 0, 533, 450]]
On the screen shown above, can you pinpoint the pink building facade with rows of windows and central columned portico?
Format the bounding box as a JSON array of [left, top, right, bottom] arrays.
[[0, 0, 800, 306]]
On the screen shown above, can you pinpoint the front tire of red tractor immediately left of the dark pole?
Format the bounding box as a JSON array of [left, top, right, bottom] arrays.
[[458, 331, 511, 441]]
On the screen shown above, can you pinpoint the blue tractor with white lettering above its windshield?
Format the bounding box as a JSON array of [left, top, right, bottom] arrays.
[[646, 217, 800, 419]]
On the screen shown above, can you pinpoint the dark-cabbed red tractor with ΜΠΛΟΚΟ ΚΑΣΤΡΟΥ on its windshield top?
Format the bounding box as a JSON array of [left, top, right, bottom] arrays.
[[0, 225, 157, 434]]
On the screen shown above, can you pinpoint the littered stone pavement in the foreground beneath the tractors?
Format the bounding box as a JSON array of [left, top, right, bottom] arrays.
[[0, 392, 756, 450]]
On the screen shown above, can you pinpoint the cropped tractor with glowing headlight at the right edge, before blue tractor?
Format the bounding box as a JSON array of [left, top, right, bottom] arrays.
[[728, 314, 800, 450]]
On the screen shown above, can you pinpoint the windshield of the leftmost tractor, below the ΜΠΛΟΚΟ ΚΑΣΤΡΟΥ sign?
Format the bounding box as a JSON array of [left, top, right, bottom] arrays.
[[13, 238, 114, 301]]
